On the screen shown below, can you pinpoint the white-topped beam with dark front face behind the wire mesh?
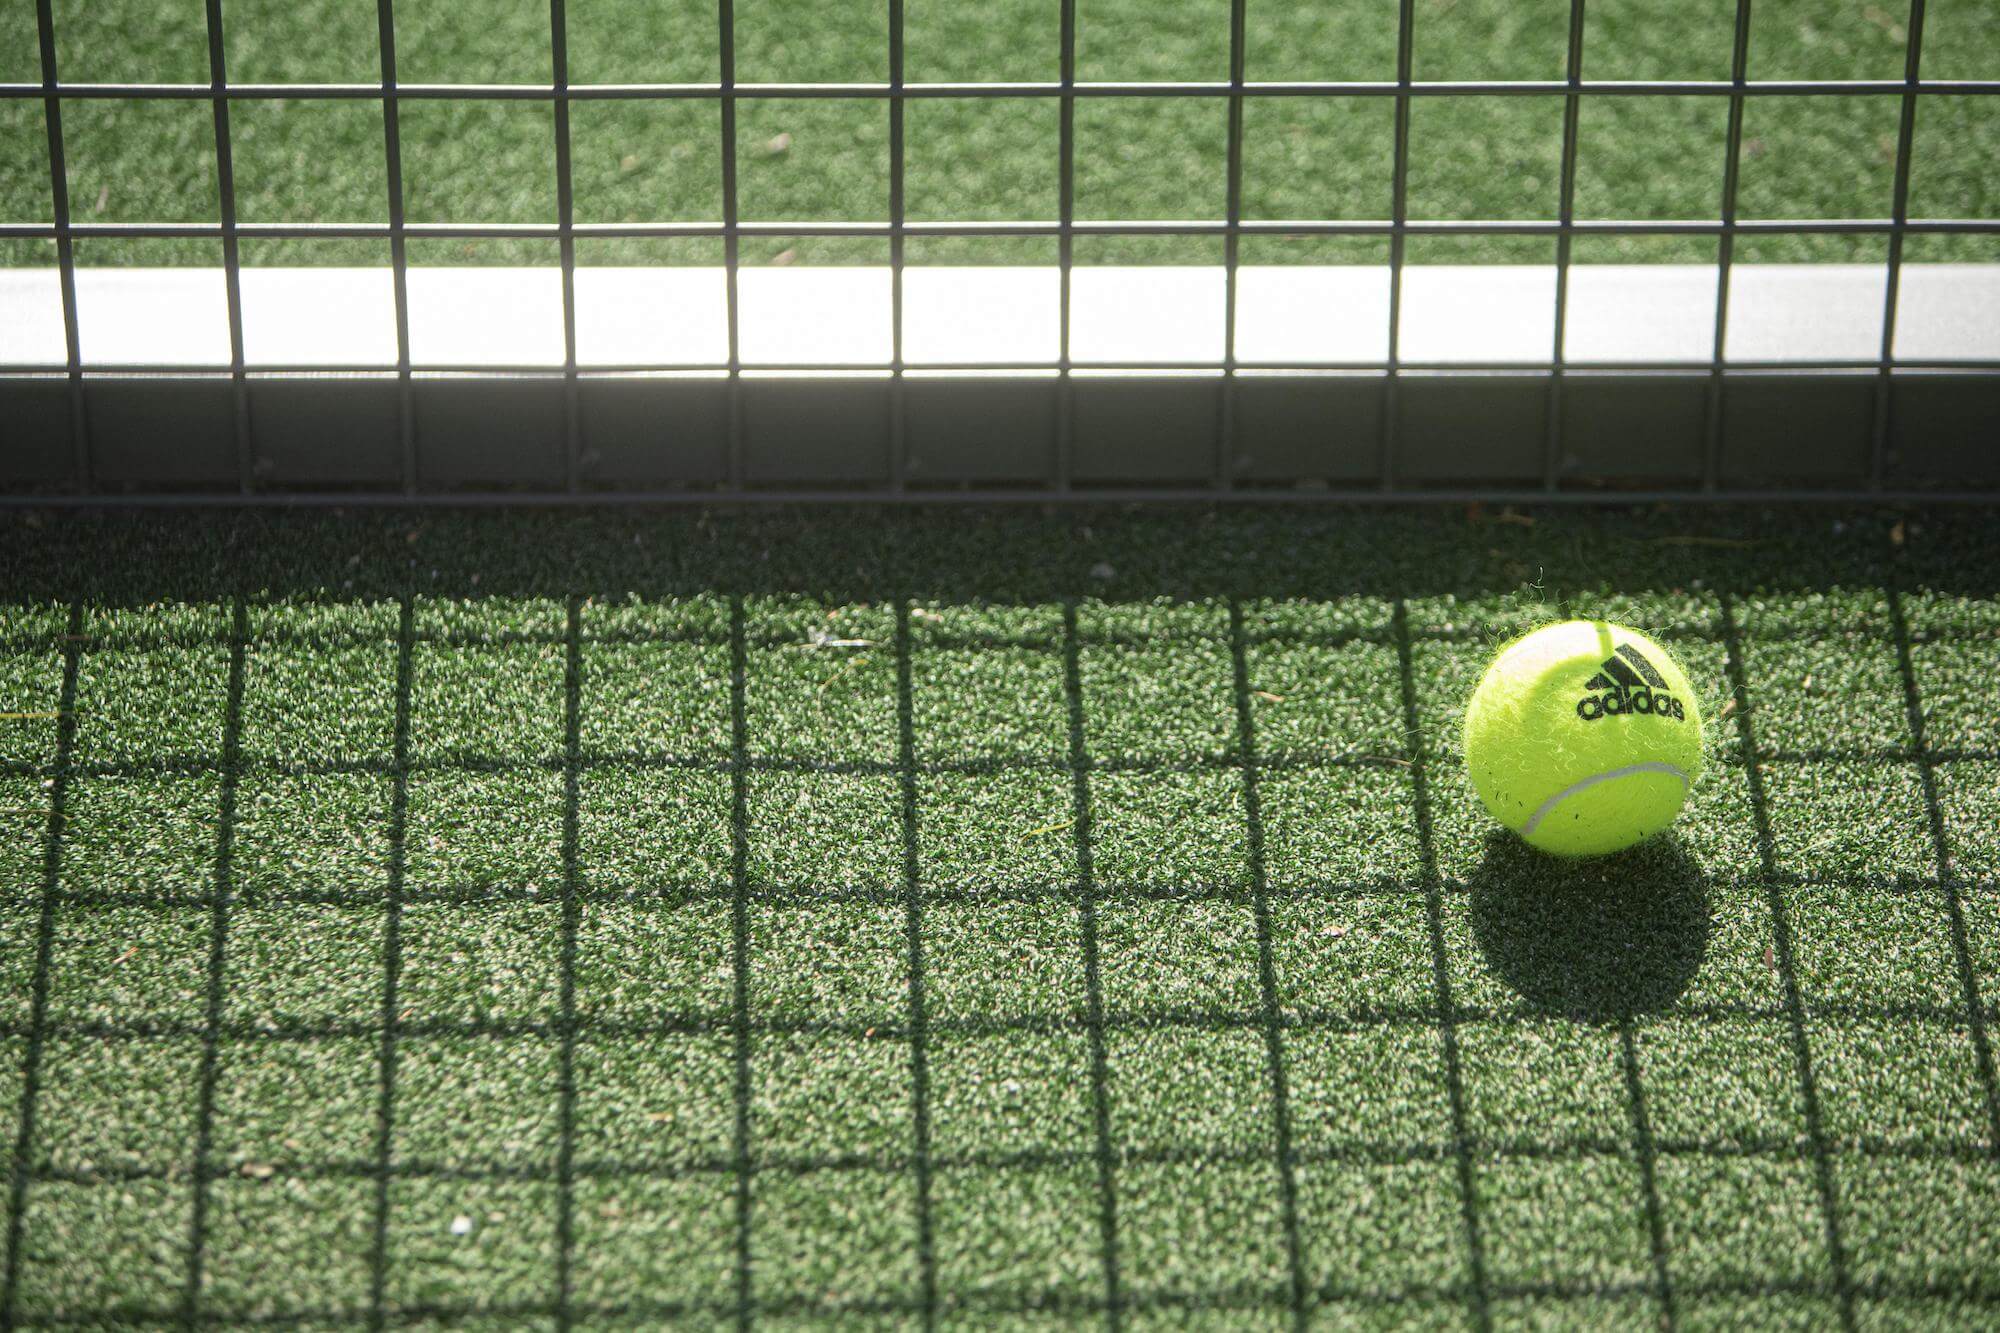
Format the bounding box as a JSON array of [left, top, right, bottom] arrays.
[[0, 264, 2000, 500]]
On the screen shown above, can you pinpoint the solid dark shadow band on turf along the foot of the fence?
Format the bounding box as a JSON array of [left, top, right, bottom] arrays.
[[0, 508, 2000, 614]]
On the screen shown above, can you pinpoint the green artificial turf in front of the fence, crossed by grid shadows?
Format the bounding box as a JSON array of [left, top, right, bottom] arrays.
[[0, 510, 2000, 1327]]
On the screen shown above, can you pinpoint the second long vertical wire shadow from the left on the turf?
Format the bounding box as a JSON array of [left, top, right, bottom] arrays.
[[180, 594, 250, 1323]]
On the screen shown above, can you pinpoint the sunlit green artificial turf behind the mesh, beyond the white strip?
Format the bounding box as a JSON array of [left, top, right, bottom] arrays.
[[0, 0, 2000, 264]]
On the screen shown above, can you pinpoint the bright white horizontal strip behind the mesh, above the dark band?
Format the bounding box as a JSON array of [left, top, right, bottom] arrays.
[[0, 264, 2000, 368]]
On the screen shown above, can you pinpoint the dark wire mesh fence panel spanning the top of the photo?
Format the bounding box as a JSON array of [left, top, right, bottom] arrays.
[[0, 0, 2000, 498]]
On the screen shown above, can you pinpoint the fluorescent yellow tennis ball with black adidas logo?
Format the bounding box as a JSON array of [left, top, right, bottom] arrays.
[[1466, 620, 1702, 857]]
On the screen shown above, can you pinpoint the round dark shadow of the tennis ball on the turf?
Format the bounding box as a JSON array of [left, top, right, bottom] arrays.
[[1468, 833, 1710, 1021]]
